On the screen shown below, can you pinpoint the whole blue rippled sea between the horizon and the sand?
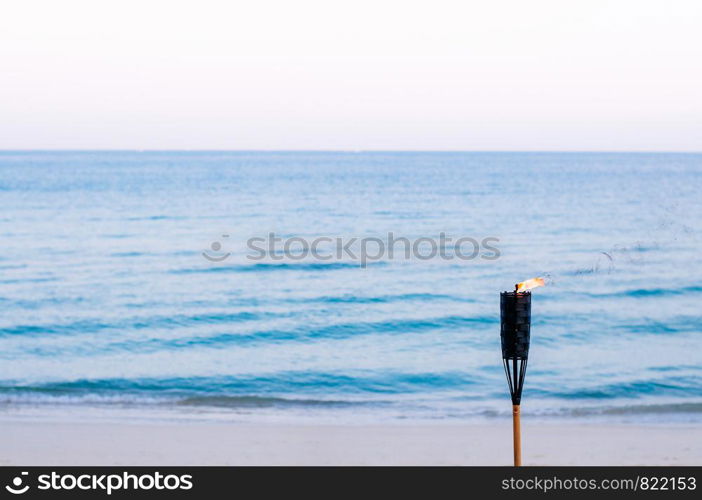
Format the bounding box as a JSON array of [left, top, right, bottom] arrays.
[[0, 151, 702, 422]]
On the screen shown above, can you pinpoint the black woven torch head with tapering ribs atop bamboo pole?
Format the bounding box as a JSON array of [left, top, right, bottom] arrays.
[[500, 292, 531, 405]]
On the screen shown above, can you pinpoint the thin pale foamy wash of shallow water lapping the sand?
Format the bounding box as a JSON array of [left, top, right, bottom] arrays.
[[0, 392, 702, 424]]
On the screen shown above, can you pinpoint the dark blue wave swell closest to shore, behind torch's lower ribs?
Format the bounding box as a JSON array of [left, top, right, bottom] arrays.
[[12, 371, 702, 401]]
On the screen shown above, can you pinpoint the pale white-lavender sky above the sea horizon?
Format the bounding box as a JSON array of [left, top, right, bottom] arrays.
[[0, 0, 702, 151]]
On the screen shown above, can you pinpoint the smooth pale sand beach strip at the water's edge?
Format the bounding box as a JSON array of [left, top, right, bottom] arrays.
[[0, 420, 702, 465]]
